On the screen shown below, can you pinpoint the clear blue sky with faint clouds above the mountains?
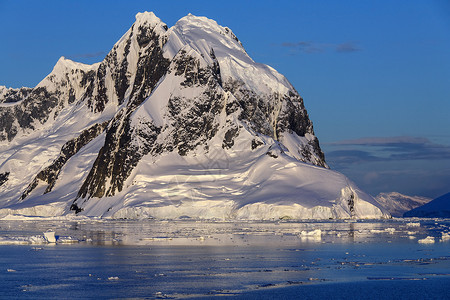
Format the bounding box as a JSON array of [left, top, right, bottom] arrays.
[[0, 0, 450, 197]]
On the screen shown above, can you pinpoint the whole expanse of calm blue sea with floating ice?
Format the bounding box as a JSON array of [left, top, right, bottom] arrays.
[[0, 219, 450, 299]]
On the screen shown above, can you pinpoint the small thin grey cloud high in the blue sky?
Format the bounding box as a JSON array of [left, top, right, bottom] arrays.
[[281, 41, 362, 54]]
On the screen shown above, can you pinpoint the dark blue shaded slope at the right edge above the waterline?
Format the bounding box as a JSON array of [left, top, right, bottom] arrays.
[[403, 193, 450, 218]]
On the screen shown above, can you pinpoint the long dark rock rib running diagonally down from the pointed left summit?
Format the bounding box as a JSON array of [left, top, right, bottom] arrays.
[[74, 24, 169, 203]]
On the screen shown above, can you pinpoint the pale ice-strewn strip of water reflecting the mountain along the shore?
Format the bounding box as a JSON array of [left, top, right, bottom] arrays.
[[0, 219, 450, 247]]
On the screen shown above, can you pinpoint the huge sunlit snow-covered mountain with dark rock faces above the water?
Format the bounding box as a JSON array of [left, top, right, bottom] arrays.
[[0, 12, 388, 219]]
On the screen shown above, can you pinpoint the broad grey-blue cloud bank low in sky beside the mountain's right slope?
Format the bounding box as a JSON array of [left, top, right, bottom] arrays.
[[322, 136, 450, 197]]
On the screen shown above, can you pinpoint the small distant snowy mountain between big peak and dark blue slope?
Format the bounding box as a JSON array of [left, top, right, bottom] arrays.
[[375, 192, 431, 217]]
